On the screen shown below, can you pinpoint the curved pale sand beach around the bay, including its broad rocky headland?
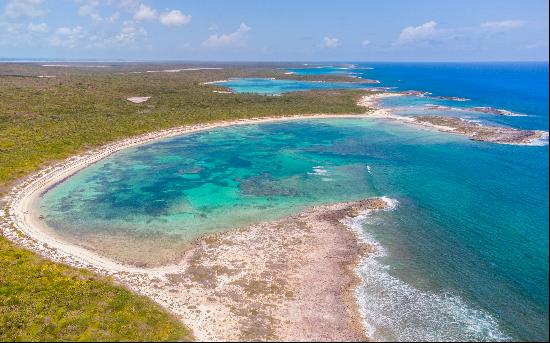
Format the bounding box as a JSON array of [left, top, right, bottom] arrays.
[[0, 101, 406, 341]]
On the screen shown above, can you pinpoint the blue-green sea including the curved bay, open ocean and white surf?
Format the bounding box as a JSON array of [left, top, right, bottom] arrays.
[[39, 63, 549, 340]]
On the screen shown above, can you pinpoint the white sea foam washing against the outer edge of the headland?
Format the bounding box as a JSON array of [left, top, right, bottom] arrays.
[[344, 197, 511, 341]]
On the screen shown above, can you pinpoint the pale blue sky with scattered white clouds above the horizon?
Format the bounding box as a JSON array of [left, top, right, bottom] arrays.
[[0, 0, 548, 61]]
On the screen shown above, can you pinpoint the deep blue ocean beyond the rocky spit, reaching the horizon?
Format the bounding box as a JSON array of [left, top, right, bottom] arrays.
[[291, 62, 549, 130]]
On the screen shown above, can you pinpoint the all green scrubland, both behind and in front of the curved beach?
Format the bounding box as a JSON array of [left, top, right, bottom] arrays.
[[0, 64, 362, 341]]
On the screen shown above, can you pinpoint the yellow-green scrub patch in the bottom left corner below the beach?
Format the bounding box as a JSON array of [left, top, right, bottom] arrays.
[[0, 238, 191, 341]]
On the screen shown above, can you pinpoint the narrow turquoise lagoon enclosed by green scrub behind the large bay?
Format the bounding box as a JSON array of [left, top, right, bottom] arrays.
[[216, 78, 378, 95]]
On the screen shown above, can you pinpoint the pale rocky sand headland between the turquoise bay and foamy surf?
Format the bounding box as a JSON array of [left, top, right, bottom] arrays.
[[123, 199, 392, 341]]
